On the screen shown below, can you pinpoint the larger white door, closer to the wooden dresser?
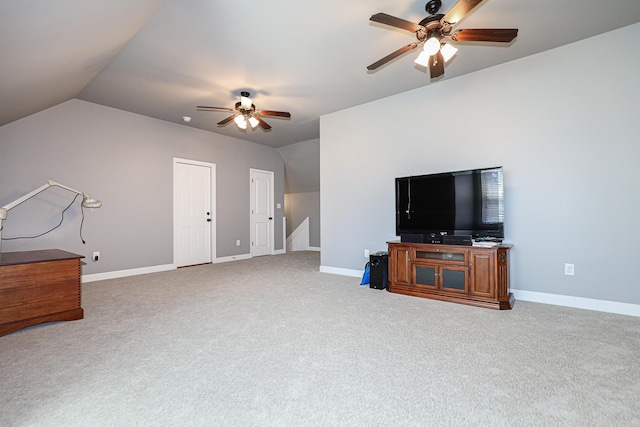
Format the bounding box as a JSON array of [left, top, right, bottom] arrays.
[[173, 159, 215, 267]]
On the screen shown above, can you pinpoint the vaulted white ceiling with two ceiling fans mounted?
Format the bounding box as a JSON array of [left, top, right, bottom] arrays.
[[0, 0, 640, 147]]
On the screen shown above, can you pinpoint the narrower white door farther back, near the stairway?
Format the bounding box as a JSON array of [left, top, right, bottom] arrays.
[[250, 169, 273, 256]]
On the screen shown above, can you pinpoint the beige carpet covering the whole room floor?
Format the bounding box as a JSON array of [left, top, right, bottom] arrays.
[[0, 252, 640, 426]]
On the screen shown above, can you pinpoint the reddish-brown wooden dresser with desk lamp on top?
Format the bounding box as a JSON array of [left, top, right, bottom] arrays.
[[0, 249, 84, 336]]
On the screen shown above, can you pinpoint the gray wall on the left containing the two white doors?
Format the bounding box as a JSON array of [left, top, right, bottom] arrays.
[[0, 100, 284, 274]]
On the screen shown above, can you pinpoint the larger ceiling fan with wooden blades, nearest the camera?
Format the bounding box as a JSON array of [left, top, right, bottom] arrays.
[[367, 0, 518, 78]]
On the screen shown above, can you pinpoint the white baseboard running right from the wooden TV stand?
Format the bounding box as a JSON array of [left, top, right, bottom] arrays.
[[511, 289, 640, 317]]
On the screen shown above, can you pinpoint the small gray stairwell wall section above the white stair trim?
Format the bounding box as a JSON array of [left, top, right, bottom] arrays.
[[284, 191, 320, 248]]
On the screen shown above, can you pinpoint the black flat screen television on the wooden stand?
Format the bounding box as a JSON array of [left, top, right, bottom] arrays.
[[396, 167, 504, 241]]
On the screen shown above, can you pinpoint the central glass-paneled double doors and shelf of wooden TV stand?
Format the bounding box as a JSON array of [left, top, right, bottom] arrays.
[[412, 248, 469, 294]]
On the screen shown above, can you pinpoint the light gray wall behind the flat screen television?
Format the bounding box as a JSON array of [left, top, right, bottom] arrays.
[[320, 24, 640, 304]]
